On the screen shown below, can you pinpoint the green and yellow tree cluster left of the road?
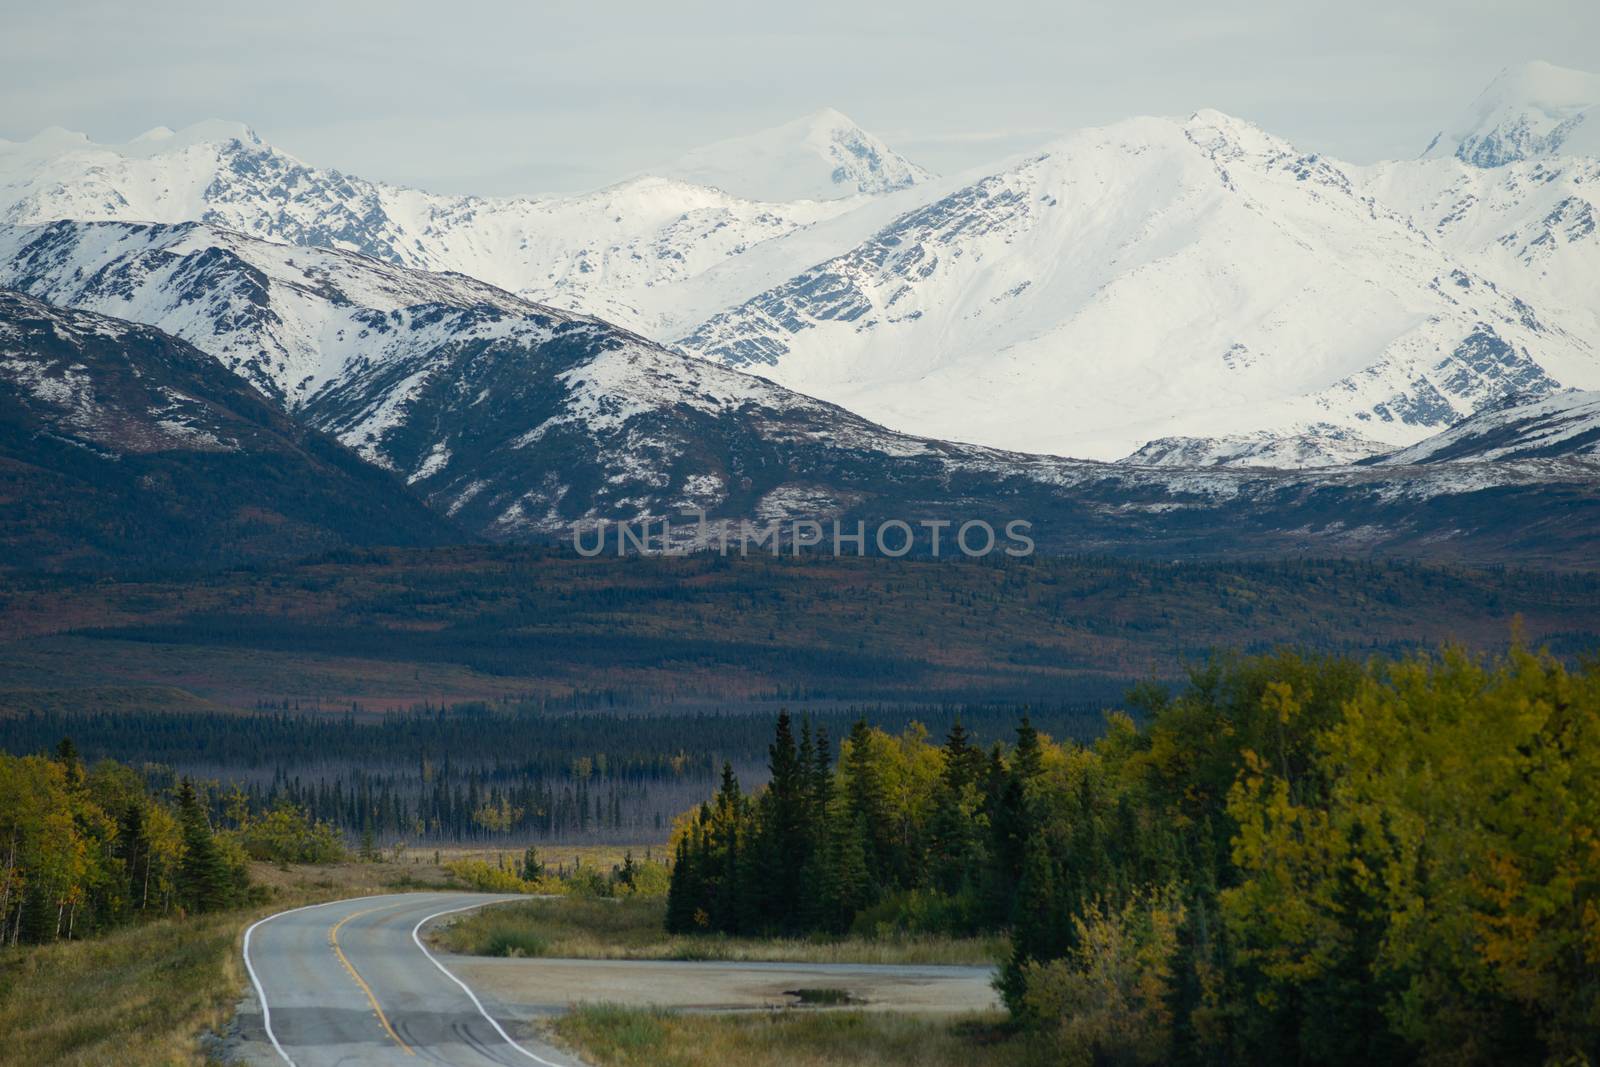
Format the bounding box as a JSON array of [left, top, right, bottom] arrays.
[[0, 741, 344, 944]]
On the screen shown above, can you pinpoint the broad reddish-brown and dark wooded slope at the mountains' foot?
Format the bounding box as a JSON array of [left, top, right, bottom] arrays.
[[0, 547, 1600, 715]]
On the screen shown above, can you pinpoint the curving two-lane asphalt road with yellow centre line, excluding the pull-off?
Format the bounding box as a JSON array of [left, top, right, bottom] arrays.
[[238, 893, 581, 1067]]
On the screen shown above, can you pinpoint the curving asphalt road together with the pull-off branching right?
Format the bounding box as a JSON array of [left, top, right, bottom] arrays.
[[226, 893, 998, 1067]]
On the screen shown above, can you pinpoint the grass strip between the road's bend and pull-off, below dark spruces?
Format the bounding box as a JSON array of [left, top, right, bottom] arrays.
[[434, 897, 1005, 965]]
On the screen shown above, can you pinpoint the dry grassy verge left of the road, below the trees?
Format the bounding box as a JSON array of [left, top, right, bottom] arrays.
[[0, 864, 448, 1067]]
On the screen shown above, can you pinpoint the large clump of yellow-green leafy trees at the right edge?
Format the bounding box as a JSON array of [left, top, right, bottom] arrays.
[[1221, 649, 1600, 1062]]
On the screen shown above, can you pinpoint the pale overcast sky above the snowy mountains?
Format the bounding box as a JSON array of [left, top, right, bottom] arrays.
[[0, 0, 1600, 194]]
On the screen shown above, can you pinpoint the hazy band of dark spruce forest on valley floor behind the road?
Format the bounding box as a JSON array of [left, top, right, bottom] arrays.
[[0, 704, 1104, 845]]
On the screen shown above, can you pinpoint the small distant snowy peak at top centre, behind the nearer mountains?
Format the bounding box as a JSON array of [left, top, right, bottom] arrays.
[[656, 107, 931, 202]]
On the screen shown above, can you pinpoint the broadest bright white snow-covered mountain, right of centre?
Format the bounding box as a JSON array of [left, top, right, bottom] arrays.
[[682, 112, 1600, 458]]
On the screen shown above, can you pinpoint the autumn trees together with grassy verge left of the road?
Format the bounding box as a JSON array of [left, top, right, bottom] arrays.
[[0, 742, 416, 1067]]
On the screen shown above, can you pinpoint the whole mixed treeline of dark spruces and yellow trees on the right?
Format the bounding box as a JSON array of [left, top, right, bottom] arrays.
[[666, 649, 1600, 1064]]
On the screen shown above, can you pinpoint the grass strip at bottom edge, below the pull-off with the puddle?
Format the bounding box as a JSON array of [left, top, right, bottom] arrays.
[[552, 1005, 1061, 1067]]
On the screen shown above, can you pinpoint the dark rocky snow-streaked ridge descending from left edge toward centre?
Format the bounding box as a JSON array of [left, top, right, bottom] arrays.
[[0, 222, 1072, 539]]
